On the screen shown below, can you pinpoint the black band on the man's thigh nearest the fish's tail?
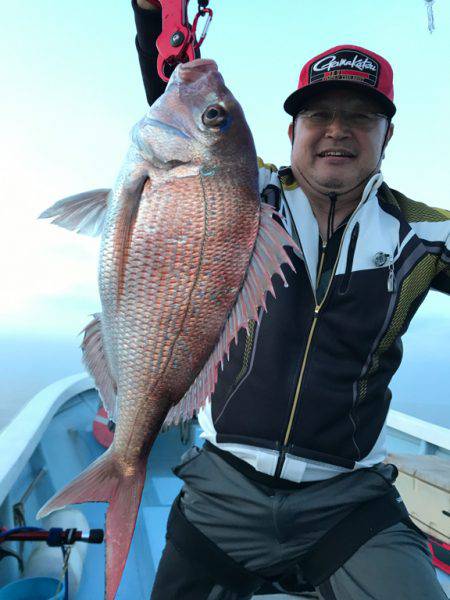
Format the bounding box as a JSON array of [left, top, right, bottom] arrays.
[[167, 495, 265, 595]]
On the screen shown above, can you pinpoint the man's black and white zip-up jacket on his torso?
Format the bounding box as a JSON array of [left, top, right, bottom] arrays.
[[199, 163, 450, 481]]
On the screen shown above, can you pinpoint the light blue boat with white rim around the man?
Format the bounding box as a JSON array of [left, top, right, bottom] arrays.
[[0, 373, 450, 600]]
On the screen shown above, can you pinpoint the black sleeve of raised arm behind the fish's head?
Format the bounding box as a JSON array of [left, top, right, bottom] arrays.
[[132, 0, 166, 105]]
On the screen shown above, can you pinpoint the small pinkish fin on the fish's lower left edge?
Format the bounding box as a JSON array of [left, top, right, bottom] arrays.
[[81, 314, 117, 422]]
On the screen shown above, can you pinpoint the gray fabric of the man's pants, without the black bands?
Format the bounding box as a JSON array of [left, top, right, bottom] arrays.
[[170, 448, 447, 600]]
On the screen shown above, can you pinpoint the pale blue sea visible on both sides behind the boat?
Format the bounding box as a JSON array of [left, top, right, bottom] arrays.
[[0, 294, 450, 430]]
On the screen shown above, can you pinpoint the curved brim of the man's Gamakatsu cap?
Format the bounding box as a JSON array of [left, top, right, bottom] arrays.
[[284, 81, 397, 119]]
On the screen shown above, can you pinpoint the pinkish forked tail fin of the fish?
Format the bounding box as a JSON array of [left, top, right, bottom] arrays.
[[36, 447, 146, 600]]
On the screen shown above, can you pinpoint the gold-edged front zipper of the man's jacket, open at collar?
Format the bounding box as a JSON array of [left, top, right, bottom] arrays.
[[274, 218, 356, 477]]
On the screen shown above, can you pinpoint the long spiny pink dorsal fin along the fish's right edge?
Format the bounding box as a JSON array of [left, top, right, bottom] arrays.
[[163, 203, 299, 428]]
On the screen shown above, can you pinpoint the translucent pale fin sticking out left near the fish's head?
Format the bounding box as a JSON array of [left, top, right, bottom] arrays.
[[39, 189, 111, 237]]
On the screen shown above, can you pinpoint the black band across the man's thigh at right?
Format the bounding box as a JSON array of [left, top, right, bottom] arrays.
[[301, 487, 411, 587]]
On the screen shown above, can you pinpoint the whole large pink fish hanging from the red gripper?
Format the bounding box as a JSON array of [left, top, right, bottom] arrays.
[[37, 59, 297, 600]]
